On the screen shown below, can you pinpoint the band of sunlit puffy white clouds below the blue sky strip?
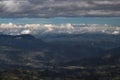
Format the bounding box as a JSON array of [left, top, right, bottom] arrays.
[[0, 23, 120, 36]]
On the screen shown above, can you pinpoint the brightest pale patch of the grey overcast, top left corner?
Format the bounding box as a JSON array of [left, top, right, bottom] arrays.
[[0, 0, 30, 13]]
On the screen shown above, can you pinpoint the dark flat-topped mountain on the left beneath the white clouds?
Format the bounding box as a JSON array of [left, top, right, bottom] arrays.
[[0, 34, 45, 50]]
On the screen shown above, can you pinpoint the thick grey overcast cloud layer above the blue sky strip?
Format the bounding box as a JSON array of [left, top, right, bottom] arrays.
[[0, 0, 120, 18]]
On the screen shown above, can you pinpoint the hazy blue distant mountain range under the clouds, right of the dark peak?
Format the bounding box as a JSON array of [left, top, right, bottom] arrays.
[[41, 33, 120, 49]]
